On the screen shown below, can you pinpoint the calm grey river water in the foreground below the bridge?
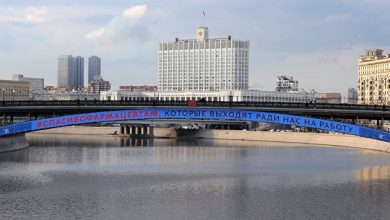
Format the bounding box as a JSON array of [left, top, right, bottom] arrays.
[[0, 135, 390, 220]]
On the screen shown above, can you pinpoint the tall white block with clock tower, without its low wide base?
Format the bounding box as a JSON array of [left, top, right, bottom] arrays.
[[158, 27, 249, 92]]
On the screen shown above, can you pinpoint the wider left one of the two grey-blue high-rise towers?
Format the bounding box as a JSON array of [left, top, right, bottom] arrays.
[[57, 55, 84, 89]]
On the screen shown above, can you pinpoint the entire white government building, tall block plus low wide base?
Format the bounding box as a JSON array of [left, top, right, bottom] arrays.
[[100, 27, 314, 102]]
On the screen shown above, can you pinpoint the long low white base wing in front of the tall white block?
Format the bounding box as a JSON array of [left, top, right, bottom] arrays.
[[100, 90, 314, 103]]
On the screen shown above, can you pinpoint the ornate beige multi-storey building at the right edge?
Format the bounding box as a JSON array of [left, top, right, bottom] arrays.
[[358, 49, 390, 105]]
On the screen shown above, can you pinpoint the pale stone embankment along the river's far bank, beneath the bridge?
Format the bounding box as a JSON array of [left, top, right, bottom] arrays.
[[28, 126, 390, 152]]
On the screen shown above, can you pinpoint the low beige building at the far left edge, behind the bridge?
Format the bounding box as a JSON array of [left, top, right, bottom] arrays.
[[0, 80, 31, 101]]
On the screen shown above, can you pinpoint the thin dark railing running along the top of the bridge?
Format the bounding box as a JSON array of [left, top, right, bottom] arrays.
[[0, 100, 390, 111]]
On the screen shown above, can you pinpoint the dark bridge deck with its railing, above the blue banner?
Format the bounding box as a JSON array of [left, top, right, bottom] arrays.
[[0, 100, 390, 120]]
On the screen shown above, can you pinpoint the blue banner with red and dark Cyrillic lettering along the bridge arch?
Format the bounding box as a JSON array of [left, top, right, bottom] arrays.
[[0, 108, 390, 142]]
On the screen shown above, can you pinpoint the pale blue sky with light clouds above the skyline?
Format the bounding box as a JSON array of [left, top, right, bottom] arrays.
[[0, 0, 390, 94]]
